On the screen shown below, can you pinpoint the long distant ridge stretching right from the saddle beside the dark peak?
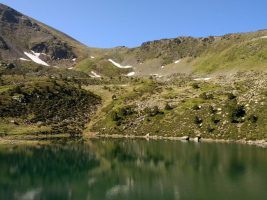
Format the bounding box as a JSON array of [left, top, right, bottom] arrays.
[[77, 30, 267, 77]]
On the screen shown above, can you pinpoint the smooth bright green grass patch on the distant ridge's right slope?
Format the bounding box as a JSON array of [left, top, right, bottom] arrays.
[[193, 39, 267, 73]]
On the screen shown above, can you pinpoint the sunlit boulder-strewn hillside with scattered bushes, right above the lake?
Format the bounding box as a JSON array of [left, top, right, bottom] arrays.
[[91, 72, 267, 140]]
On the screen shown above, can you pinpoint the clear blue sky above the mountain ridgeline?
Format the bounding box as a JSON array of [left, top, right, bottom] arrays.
[[0, 0, 267, 47]]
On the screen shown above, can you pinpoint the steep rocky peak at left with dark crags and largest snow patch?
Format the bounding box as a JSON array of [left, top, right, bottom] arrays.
[[0, 4, 87, 66]]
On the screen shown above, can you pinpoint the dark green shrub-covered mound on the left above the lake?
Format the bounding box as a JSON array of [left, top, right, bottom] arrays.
[[0, 80, 100, 135]]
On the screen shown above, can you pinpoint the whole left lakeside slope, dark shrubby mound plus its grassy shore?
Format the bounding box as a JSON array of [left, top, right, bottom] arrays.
[[0, 65, 101, 136]]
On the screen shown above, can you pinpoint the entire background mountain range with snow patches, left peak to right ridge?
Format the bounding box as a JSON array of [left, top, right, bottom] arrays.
[[0, 4, 267, 78]]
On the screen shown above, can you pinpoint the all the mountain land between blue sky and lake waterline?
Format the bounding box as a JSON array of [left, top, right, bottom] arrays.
[[0, 4, 267, 140]]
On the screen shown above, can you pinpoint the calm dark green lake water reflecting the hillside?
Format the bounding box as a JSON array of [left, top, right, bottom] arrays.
[[0, 139, 267, 200]]
